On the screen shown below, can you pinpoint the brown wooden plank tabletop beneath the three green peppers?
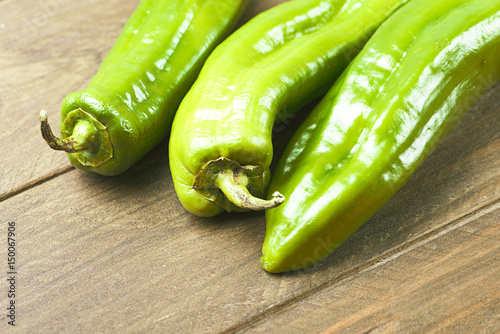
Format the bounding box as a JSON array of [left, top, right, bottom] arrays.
[[0, 0, 500, 333]]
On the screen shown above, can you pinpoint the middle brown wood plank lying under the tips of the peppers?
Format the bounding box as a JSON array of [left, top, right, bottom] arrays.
[[0, 80, 500, 332]]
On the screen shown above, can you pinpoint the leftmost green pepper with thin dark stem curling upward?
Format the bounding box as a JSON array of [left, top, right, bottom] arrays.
[[40, 0, 248, 175]]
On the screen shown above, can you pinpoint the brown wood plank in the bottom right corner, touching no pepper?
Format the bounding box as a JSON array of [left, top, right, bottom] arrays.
[[242, 202, 500, 334]]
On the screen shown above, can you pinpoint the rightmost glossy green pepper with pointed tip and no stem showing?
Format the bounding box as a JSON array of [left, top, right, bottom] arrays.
[[261, 0, 500, 272]]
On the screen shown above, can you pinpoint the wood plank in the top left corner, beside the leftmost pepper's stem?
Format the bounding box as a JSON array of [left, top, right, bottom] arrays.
[[0, 0, 139, 196]]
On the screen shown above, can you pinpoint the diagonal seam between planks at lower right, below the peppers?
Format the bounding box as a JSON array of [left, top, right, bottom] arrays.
[[219, 196, 500, 334]]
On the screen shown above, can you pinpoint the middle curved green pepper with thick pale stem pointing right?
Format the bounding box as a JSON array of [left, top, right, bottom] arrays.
[[169, 0, 407, 216]]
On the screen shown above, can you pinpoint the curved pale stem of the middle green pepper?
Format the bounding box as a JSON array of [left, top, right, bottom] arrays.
[[215, 169, 285, 211]]
